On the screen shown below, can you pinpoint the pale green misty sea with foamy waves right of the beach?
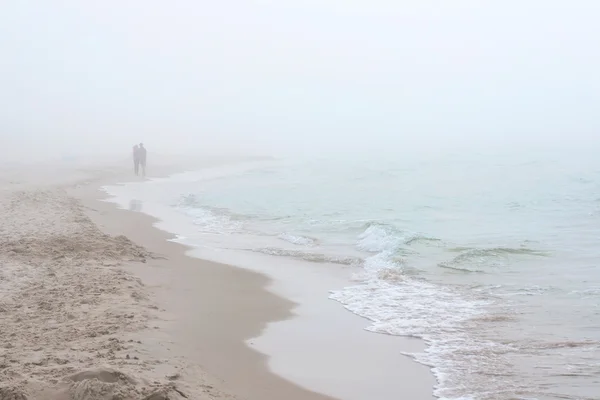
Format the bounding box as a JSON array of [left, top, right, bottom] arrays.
[[105, 150, 600, 400]]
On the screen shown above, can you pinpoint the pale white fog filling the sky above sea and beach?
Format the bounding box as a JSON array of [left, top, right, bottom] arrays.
[[0, 0, 600, 158]]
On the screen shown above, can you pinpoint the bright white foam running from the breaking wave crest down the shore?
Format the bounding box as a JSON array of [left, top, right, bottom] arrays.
[[330, 224, 488, 400]]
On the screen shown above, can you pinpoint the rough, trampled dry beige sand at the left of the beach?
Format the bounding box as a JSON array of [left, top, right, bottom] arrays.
[[0, 188, 195, 400]]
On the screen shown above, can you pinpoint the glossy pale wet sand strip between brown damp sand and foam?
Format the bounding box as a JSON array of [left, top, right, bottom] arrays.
[[83, 163, 435, 400]]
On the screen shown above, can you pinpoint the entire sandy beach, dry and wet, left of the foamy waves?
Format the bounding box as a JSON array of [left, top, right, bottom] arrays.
[[0, 160, 433, 400]]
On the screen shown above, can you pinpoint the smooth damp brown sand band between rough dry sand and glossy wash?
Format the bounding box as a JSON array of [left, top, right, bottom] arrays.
[[70, 171, 334, 400]]
